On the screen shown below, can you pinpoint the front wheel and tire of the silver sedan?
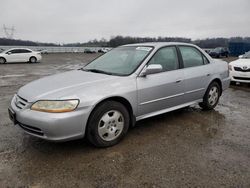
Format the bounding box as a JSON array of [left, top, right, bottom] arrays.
[[86, 101, 130, 147]]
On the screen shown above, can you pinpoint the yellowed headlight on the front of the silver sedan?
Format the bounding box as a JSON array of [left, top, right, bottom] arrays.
[[30, 99, 79, 113]]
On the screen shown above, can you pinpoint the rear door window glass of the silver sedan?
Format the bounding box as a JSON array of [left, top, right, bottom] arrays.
[[179, 46, 204, 68]]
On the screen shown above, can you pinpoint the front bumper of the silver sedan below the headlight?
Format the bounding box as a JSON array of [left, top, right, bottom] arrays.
[[10, 97, 90, 141]]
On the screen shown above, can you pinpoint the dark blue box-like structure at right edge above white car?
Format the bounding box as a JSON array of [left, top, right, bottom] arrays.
[[228, 42, 250, 56]]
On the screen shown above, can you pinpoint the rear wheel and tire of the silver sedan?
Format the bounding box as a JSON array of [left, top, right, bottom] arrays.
[[199, 82, 221, 110]]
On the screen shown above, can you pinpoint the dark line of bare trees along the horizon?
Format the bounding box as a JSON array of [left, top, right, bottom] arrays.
[[0, 36, 250, 48]]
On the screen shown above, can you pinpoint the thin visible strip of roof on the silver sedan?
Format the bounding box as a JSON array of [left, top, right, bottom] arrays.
[[123, 42, 195, 48]]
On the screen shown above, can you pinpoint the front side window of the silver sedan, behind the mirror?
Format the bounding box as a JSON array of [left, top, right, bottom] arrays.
[[148, 47, 179, 71]]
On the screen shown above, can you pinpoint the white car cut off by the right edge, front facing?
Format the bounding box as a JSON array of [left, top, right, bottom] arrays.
[[229, 51, 250, 83]]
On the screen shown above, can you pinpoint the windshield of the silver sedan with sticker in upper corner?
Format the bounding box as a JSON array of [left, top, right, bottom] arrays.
[[83, 46, 153, 76]]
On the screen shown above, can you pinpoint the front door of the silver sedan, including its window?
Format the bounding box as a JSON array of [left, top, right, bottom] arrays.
[[137, 46, 184, 116]]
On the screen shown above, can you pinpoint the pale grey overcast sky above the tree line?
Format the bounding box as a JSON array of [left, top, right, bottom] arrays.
[[0, 0, 250, 43]]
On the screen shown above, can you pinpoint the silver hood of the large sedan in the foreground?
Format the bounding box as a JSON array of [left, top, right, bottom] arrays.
[[17, 70, 120, 102]]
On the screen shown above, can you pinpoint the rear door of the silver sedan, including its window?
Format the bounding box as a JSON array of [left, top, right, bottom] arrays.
[[179, 46, 212, 102]]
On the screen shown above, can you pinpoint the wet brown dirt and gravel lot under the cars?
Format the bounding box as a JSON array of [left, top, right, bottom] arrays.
[[0, 54, 250, 188]]
